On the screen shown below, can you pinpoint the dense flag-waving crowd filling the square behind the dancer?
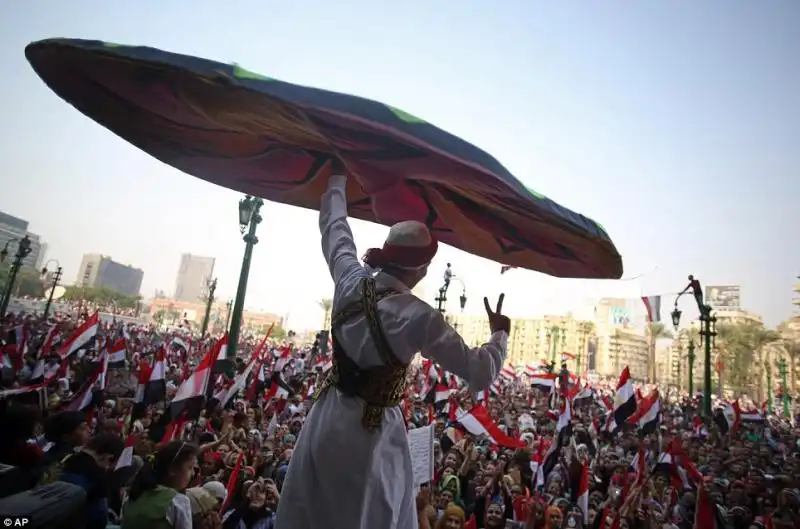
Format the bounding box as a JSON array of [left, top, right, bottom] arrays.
[[0, 306, 800, 529]]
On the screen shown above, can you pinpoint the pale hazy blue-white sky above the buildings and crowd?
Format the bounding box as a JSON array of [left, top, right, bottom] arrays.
[[0, 0, 800, 328]]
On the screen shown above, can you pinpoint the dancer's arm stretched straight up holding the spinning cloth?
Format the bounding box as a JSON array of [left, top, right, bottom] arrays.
[[319, 173, 361, 284]]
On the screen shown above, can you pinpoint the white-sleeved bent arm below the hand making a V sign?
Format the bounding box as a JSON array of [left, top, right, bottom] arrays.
[[420, 309, 508, 391]]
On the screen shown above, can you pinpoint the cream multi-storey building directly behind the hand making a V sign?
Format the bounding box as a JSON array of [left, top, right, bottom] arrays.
[[448, 314, 594, 373]]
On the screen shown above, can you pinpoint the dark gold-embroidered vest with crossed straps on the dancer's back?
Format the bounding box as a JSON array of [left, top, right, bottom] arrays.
[[315, 277, 408, 430]]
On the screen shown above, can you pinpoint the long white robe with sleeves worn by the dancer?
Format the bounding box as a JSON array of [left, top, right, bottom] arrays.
[[275, 176, 508, 529]]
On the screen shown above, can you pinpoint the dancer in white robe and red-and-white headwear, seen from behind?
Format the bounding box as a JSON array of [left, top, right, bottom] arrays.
[[276, 165, 510, 529]]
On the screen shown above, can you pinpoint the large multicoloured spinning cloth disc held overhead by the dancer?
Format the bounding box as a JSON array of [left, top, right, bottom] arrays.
[[25, 39, 622, 279]]
